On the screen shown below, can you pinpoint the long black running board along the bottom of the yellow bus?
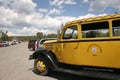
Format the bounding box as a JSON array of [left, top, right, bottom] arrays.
[[55, 68, 120, 80]]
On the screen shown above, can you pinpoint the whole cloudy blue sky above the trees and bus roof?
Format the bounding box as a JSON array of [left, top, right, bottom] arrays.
[[0, 0, 120, 36]]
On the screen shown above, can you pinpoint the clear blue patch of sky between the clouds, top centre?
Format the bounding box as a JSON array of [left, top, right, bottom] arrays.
[[33, 0, 117, 17]]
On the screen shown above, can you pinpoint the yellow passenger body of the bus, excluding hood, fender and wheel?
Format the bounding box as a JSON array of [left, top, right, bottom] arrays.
[[57, 14, 120, 69]]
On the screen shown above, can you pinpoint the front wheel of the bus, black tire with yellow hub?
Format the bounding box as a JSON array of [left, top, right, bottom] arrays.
[[34, 58, 49, 76]]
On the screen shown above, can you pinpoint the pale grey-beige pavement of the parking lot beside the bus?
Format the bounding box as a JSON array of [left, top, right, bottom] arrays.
[[0, 42, 106, 80]]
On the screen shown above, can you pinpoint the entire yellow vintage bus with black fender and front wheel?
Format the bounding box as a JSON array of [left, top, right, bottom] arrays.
[[30, 14, 120, 79]]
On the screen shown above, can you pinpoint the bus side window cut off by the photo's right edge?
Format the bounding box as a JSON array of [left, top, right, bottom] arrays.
[[112, 20, 120, 36]]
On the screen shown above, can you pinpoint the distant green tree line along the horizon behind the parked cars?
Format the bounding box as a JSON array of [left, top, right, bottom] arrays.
[[0, 31, 57, 41]]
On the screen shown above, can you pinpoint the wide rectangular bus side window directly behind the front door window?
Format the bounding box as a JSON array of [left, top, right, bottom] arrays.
[[81, 21, 109, 38]]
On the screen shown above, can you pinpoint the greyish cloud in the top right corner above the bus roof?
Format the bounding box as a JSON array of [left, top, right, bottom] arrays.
[[89, 0, 120, 11]]
